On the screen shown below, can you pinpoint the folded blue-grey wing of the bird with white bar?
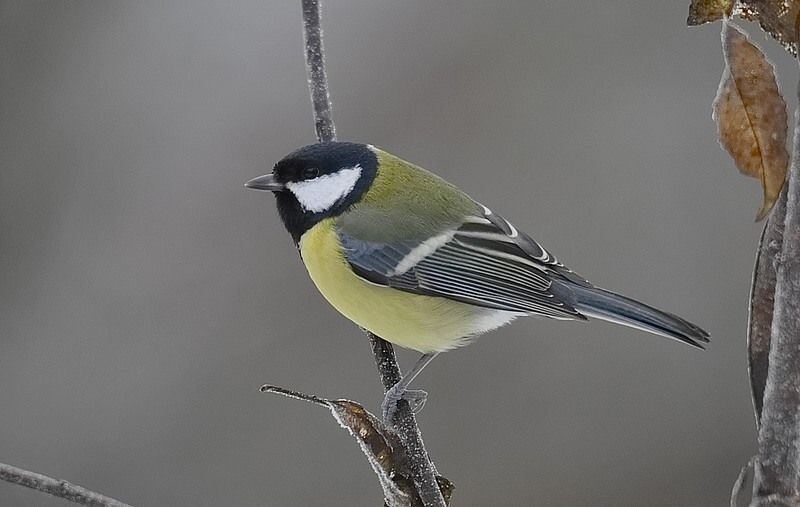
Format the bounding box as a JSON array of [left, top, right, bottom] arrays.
[[338, 204, 588, 319]]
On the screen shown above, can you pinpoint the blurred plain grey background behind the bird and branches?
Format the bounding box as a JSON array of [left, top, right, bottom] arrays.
[[0, 0, 795, 506]]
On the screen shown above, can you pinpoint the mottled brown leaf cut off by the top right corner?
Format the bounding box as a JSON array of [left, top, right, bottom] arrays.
[[734, 0, 800, 55]]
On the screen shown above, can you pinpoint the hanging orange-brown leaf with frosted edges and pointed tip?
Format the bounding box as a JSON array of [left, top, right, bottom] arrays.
[[714, 21, 789, 220]]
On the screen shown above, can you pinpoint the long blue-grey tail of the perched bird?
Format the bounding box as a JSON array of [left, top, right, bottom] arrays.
[[564, 283, 710, 349]]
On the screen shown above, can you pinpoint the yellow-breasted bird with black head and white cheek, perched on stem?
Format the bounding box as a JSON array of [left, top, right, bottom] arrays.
[[245, 141, 709, 422]]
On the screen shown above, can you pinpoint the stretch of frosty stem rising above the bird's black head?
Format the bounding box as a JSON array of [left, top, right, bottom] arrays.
[[302, 0, 336, 143]]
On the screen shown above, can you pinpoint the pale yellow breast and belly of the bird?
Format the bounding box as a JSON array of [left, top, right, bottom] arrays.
[[300, 219, 514, 352]]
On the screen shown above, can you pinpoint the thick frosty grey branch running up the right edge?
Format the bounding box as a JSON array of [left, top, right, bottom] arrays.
[[751, 64, 800, 506]]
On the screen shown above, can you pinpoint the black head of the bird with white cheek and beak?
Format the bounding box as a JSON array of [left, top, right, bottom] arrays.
[[245, 142, 378, 243]]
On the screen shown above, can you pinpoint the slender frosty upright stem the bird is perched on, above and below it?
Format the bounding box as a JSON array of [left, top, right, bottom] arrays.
[[302, 0, 446, 507]]
